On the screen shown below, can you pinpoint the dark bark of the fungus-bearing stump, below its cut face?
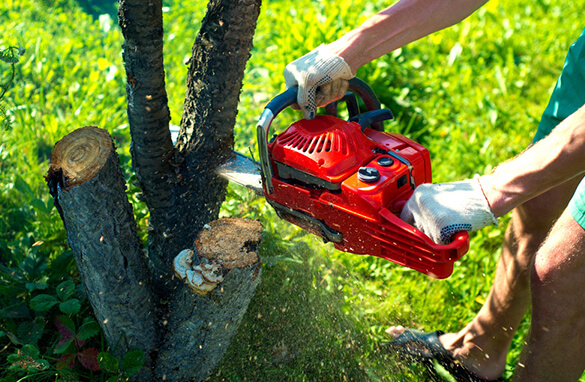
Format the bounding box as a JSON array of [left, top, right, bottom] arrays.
[[156, 264, 261, 382]]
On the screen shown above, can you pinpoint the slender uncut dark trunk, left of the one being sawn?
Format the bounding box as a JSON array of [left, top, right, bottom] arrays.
[[118, 0, 177, 290]]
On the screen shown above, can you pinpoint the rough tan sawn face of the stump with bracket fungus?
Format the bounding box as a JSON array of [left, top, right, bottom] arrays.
[[195, 218, 263, 269]]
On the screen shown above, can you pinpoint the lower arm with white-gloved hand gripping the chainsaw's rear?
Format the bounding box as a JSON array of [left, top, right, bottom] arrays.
[[400, 106, 585, 244]]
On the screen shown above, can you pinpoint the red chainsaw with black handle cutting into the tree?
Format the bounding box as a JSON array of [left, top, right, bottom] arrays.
[[216, 78, 469, 279]]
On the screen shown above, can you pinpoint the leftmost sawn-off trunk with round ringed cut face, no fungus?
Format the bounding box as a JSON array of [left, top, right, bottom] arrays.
[[47, 127, 157, 381]]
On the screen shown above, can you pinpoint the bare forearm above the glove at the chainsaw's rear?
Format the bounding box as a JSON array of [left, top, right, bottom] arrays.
[[480, 106, 585, 217]]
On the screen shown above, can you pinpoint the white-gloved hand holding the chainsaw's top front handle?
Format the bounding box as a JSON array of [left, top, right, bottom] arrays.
[[284, 45, 354, 119]]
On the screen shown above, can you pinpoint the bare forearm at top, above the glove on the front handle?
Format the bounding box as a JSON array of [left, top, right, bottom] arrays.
[[329, 0, 487, 73]]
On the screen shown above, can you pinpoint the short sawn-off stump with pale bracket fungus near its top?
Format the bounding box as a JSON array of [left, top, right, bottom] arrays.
[[156, 219, 262, 381]]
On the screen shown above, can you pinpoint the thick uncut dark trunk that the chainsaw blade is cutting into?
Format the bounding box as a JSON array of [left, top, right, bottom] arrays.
[[171, 0, 261, 248]]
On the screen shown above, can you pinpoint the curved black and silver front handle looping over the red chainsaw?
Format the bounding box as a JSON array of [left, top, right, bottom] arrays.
[[256, 77, 384, 194]]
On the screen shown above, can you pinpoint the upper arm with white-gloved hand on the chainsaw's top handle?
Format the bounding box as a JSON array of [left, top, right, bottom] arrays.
[[284, 0, 487, 119]]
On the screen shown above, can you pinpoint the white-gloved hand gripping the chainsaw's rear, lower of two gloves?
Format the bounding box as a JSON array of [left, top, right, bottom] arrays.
[[400, 175, 498, 244]]
